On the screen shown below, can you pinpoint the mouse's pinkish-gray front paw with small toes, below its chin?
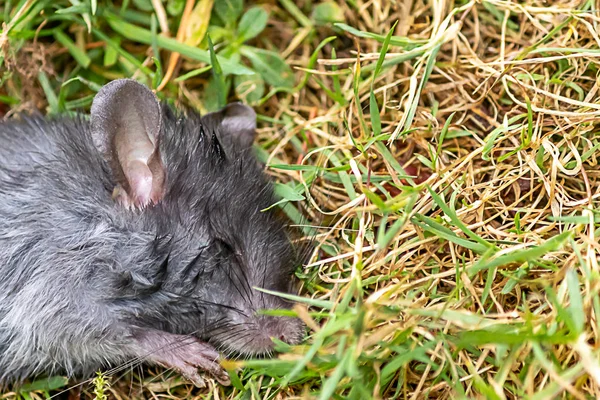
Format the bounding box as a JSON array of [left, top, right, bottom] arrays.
[[129, 329, 231, 387]]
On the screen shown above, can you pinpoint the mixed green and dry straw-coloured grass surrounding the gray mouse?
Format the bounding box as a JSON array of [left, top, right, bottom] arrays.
[[0, 0, 600, 400]]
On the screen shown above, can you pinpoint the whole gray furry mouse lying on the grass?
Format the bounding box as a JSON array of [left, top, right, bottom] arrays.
[[0, 79, 304, 384]]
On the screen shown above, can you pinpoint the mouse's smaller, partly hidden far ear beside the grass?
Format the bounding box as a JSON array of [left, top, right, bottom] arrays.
[[203, 103, 256, 151]]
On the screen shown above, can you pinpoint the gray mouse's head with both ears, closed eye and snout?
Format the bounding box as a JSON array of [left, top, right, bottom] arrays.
[[91, 80, 303, 355]]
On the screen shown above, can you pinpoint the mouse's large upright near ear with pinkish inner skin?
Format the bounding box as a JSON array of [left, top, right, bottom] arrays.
[[91, 79, 165, 208]]
